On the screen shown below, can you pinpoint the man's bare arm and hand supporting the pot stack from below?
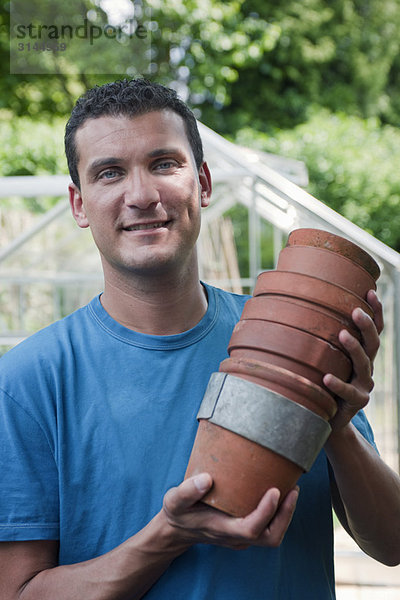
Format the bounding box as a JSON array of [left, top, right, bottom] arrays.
[[0, 482, 298, 600]]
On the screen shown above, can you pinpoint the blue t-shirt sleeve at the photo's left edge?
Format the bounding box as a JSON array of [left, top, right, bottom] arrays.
[[0, 390, 59, 541]]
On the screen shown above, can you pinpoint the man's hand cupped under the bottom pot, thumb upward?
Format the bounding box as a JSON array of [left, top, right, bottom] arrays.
[[163, 473, 298, 549]]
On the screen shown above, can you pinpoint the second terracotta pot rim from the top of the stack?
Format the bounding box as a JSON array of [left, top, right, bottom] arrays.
[[277, 246, 376, 293]]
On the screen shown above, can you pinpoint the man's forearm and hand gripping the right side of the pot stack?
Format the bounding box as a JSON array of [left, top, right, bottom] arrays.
[[324, 292, 400, 566]]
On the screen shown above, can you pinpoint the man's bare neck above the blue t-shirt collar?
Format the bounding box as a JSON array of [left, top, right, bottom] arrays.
[[101, 271, 207, 335]]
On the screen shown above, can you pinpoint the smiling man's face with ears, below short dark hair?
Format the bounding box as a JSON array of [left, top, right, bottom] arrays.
[[70, 110, 211, 277]]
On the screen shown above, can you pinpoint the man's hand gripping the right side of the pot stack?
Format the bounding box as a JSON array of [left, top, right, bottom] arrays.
[[324, 290, 383, 431]]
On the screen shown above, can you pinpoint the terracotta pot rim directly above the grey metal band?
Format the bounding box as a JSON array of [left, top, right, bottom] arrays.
[[220, 358, 338, 418]]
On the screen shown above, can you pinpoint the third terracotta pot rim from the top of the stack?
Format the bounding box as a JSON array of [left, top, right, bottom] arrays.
[[253, 269, 374, 319]]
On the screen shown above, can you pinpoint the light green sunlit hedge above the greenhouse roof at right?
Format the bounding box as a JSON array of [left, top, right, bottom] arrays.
[[236, 110, 400, 251]]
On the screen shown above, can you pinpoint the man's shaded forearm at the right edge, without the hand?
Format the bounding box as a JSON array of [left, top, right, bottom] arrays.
[[325, 424, 400, 565]]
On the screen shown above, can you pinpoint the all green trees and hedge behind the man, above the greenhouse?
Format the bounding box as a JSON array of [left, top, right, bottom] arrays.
[[0, 0, 400, 250]]
